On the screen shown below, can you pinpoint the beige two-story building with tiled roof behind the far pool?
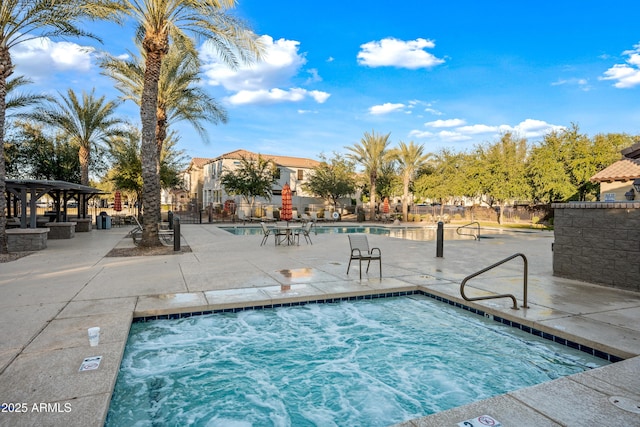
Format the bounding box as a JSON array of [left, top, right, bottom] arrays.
[[202, 149, 324, 215]]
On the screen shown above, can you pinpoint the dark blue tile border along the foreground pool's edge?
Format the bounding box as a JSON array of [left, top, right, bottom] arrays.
[[133, 290, 624, 363]]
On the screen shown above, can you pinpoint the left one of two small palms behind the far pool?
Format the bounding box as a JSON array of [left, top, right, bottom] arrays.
[[345, 131, 391, 219]]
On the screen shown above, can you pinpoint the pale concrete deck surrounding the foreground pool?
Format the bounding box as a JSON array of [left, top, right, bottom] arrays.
[[0, 224, 640, 427]]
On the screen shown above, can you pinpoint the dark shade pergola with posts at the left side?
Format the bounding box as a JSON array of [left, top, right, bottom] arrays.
[[5, 179, 105, 228]]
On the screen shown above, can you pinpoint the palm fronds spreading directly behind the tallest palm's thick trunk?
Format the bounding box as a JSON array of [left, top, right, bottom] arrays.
[[100, 38, 227, 159]]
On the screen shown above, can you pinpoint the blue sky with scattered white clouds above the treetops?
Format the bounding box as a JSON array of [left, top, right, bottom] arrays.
[[12, 0, 640, 164]]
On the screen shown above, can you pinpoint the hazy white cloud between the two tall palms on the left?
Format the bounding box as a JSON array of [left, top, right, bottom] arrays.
[[11, 37, 94, 80]]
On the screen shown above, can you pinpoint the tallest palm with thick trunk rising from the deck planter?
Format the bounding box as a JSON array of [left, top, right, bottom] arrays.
[[115, 0, 261, 247]]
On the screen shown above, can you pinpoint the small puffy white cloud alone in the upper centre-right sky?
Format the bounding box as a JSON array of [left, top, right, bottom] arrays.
[[358, 37, 444, 70]]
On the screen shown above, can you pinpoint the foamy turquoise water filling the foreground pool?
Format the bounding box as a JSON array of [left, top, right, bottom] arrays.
[[106, 295, 608, 426]]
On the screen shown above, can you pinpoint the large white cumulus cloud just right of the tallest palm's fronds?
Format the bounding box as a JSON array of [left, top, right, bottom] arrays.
[[200, 35, 330, 105]]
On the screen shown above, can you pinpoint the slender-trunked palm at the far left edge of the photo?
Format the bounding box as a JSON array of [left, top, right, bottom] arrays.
[[0, 0, 117, 253]]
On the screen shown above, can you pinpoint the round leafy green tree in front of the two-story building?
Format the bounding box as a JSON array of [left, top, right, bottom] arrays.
[[220, 154, 277, 211]]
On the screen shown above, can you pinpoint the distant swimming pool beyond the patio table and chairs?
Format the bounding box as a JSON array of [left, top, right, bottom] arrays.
[[219, 225, 473, 240]]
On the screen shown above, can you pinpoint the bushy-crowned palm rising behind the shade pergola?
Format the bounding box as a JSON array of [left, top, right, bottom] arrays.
[[26, 89, 123, 185]]
